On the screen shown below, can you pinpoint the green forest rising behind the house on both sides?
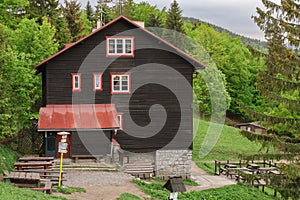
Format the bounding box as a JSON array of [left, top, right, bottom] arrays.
[[0, 0, 296, 140]]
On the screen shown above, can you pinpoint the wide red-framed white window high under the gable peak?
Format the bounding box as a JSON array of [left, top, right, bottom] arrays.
[[106, 36, 134, 56]]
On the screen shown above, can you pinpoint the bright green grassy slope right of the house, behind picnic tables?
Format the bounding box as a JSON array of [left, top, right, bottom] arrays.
[[193, 118, 274, 174]]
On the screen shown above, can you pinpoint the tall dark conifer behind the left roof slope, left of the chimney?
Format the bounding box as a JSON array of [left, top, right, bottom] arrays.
[[62, 0, 83, 41]]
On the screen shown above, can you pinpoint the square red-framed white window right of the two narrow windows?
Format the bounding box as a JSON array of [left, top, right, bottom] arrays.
[[111, 73, 130, 94]]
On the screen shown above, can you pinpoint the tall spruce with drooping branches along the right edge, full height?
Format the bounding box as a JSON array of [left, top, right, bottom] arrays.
[[242, 0, 300, 199]]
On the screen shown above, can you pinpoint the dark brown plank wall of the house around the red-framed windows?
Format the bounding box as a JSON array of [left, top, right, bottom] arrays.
[[43, 19, 193, 152]]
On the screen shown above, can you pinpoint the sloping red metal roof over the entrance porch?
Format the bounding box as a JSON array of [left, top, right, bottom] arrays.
[[38, 104, 119, 131]]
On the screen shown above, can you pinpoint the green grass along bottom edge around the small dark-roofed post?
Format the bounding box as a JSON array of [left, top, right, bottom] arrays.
[[133, 180, 274, 200]]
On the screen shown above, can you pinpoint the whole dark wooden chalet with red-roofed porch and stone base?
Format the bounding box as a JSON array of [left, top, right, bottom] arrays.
[[36, 16, 204, 176]]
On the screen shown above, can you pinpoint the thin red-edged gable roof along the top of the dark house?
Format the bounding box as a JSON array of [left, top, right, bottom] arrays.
[[35, 15, 206, 72]]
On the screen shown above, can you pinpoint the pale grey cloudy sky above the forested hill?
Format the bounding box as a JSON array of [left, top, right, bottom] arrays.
[[78, 0, 264, 40]]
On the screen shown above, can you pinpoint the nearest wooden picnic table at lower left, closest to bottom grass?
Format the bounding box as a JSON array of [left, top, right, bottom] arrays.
[[5, 172, 41, 187]]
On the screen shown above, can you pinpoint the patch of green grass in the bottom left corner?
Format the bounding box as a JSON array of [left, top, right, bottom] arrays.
[[0, 182, 66, 200]]
